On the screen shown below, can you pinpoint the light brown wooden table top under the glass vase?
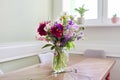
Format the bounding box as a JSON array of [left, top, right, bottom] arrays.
[[0, 54, 115, 80]]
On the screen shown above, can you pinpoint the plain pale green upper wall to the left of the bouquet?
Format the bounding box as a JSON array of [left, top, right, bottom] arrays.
[[0, 0, 52, 43]]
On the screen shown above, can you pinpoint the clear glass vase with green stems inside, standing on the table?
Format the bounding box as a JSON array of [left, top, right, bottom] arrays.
[[53, 47, 67, 73]]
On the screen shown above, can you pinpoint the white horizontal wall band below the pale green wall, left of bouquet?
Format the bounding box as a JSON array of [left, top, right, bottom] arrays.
[[0, 41, 50, 63]]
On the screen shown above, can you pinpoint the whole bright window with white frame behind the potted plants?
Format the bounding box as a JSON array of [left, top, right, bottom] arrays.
[[63, 0, 120, 23]]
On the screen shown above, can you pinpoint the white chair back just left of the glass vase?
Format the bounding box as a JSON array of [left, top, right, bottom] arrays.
[[38, 52, 54, 64]]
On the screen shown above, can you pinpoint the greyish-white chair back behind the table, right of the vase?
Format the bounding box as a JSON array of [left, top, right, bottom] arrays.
[[83, 49, 106, 58]]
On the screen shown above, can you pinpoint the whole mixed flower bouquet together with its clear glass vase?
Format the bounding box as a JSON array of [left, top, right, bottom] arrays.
[[37, 13, 84, 72]]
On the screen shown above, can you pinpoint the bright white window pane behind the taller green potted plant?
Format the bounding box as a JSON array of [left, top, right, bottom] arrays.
[[68, 0, 98, 19]]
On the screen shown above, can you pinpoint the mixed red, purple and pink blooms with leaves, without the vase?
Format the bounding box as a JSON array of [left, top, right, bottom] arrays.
[[37, 13, 84, 50]]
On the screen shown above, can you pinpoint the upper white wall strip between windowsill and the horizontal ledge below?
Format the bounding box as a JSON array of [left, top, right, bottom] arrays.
[[85, 26, 120, 43]]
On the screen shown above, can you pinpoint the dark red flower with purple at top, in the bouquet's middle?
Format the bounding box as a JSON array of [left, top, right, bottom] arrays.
[[51, 24, 63, 38]]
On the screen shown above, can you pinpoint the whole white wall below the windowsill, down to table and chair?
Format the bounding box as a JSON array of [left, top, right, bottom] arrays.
[[69, 26, 120, 57]]
